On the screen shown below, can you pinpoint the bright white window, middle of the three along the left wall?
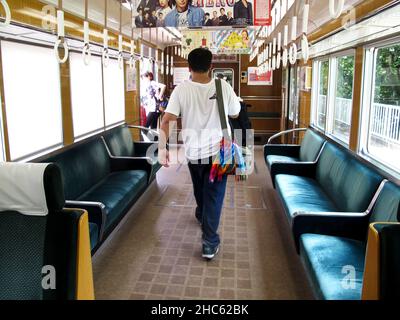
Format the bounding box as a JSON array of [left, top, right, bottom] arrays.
[[70, 53, 104, 139]]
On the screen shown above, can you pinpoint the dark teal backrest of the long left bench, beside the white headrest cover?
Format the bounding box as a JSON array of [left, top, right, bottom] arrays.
[[41, 137, 110, 200]]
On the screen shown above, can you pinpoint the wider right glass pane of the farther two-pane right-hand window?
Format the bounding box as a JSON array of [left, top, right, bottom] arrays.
[[332, 56, 354, 143]]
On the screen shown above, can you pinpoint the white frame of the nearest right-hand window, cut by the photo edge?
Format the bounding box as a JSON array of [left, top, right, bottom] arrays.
[[357, 36, 400, 179]]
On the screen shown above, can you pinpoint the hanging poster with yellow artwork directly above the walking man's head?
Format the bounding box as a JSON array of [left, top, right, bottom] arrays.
[[182, 29, 255, 54]]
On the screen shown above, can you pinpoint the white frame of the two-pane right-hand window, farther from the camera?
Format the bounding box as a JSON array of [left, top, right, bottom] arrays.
[[311, 49, 356, 148]]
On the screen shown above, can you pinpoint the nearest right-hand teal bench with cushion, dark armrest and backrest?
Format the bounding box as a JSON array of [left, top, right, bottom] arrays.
[[293, 182, 400, 300]]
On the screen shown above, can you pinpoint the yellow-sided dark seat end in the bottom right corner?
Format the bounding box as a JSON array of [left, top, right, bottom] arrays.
[[362, 222, 400, 300]]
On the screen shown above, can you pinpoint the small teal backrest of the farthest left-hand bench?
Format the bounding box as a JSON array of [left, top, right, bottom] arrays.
[[103, 126, 135, 157]]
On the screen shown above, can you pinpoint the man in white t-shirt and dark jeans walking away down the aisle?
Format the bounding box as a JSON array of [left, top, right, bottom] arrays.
[[159, 48, 240, 259]]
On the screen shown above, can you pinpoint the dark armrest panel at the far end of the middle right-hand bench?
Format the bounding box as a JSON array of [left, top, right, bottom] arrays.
[[270, 162, 317, 187]]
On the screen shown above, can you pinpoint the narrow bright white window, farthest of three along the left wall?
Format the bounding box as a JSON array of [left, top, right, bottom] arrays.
[[103, 59, 125, 126]]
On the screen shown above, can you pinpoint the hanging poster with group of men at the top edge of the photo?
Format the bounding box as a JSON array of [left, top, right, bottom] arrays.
[[132, 0, 271, 28]]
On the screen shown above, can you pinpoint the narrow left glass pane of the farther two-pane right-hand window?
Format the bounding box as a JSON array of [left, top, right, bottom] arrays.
[[316, 61, 329, 130]]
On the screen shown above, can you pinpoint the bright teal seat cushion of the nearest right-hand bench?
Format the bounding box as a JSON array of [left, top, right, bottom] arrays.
[[300, 234, 365, 300]]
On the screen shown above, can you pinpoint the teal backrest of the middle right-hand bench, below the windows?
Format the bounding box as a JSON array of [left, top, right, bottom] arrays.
[[316, 142, 383, 212]]
